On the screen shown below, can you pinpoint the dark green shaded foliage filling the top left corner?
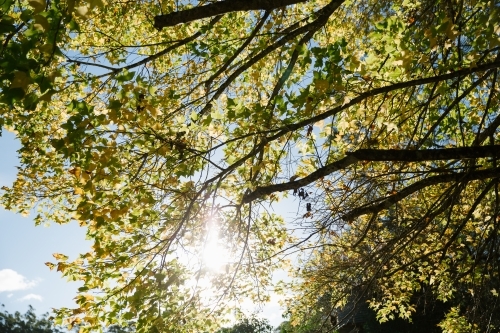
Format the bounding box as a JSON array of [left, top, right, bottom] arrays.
[[0, 0, 67, 135]]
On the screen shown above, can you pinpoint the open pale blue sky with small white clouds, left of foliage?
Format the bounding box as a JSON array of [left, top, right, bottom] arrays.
[[0, 129, 90, 314]]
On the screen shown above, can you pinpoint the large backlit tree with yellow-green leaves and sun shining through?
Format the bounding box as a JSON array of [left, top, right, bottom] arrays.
[[0, 0, 500, 332]]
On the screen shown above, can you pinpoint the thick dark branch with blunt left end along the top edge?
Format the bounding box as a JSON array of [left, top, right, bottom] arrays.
[[154, 0, 308, 30]]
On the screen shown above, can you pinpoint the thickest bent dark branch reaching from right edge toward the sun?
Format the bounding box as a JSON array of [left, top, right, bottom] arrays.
[[242, 145, 500, 202]]
